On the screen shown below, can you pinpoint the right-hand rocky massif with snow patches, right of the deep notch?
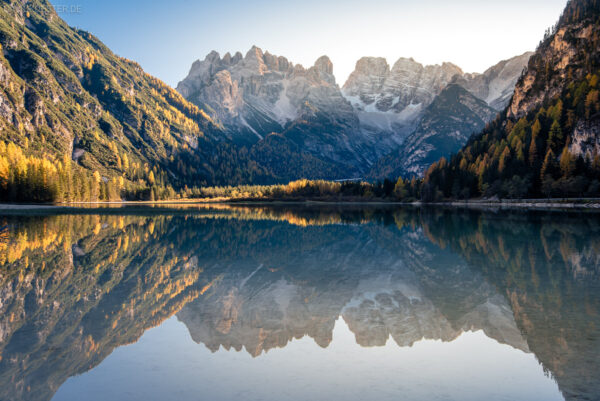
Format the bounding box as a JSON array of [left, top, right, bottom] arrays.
[[343, 52, 533, 179]]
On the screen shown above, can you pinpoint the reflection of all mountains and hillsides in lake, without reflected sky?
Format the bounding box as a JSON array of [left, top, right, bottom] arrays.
[[0, 206, 600, 400]]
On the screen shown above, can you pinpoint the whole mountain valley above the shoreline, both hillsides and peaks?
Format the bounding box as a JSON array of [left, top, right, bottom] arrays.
[[0, 0, 600, 202]]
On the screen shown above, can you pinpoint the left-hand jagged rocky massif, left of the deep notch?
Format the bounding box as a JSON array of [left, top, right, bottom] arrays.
[[177, 46, 376, 175]]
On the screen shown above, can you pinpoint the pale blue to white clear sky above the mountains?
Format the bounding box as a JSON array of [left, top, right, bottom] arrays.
[[52, 0, 566, 86]]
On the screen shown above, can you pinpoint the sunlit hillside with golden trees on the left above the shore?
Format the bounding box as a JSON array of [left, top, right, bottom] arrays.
[[0, 0, 269, 201]]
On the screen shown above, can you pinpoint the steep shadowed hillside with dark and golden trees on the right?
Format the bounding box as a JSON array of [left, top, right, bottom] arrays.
[[422, 0, 600, 200]]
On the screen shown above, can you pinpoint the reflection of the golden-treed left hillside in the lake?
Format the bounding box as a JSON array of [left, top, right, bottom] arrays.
[[0, 215, 214, 398]]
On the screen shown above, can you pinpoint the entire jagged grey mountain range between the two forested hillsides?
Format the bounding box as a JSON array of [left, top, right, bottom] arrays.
[[177, 46, 529, 178]]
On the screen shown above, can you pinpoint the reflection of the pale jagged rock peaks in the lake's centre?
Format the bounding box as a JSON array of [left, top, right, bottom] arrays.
[[177, 222, 527, 356]]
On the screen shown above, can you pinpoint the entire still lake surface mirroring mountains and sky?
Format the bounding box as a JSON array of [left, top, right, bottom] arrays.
[[0, 206, 600, 400]]
